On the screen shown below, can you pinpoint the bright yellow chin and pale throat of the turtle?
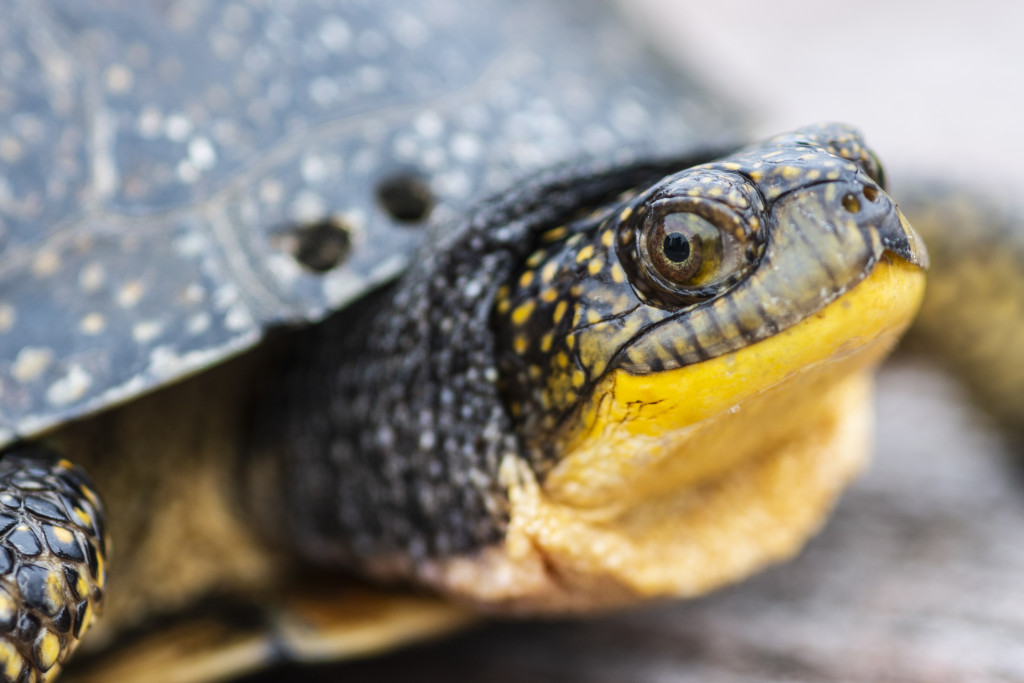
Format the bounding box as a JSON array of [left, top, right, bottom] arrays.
[[425, 257, 924, 611]]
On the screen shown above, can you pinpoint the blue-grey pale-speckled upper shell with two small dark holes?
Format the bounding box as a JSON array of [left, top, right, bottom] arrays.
[[0, 0, 727, 442]]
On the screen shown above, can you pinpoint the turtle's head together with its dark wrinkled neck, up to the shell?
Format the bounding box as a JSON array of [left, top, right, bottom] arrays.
[[270, 126, 926, 610]]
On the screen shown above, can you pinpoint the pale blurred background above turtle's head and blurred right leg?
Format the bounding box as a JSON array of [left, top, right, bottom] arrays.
[[620, 0, 1024, 191]]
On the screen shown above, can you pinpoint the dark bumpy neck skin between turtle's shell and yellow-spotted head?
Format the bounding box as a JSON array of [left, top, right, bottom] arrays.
[[260, 153, 694, 575]]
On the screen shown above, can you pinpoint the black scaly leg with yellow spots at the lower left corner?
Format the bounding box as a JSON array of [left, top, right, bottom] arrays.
[[0, 445, 108, 683]]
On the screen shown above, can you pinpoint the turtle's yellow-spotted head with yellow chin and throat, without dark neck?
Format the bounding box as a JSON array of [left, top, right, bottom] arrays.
[[462, 126, 927, 605]]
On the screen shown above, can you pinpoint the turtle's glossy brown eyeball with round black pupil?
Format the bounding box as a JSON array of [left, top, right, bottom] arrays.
[[639, 211, 744, 297]]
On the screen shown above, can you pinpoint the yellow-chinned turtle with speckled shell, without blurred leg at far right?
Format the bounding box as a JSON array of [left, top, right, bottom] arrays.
[[0, 0, 983, 681]]
